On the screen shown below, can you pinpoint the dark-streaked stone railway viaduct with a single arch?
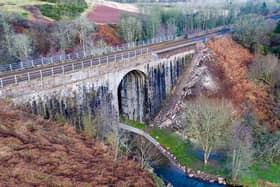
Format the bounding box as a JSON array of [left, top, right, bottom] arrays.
[[0, 29, 225, 130]]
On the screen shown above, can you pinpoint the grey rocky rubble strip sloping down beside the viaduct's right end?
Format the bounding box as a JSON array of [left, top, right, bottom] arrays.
[[154, 43, 219, 127]]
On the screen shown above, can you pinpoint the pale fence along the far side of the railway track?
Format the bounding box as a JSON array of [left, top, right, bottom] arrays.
[[0, 35, 176, 74]]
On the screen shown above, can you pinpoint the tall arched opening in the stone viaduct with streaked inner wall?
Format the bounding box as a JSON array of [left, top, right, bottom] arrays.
[[118, 70, 147, 122]]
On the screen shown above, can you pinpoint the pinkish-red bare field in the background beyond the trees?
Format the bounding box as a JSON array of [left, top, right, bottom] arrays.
[[87, 5, 132, 24]]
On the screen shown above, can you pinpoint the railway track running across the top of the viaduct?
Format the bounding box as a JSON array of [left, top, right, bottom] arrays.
[[0, 27, 230, 88]]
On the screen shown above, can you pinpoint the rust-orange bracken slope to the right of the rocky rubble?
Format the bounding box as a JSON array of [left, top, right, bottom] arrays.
[[207, 37, 279, 130]]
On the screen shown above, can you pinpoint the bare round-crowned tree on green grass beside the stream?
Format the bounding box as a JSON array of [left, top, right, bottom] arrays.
[[180, 96, 233, 165]]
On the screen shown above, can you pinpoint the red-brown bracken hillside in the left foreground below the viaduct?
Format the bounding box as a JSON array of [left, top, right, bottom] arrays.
[[0, 101, 155, 187]]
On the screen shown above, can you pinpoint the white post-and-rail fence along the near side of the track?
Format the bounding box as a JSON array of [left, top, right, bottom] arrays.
[[0, 48, 151, 88]]
